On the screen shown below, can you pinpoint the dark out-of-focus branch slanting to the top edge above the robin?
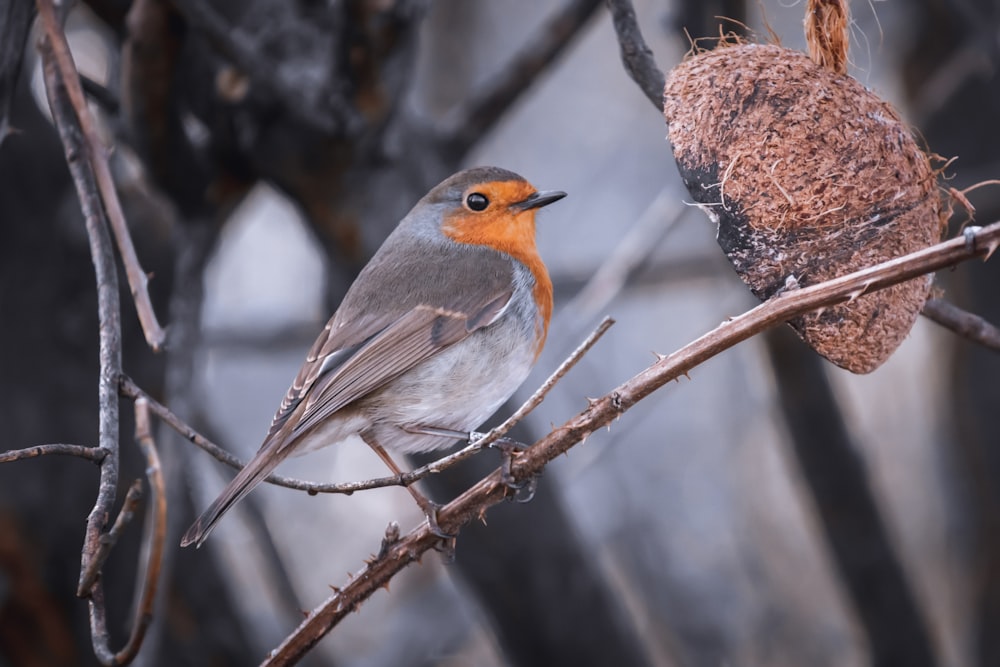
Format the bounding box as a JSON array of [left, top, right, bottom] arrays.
[[441, 0, 600, 155]]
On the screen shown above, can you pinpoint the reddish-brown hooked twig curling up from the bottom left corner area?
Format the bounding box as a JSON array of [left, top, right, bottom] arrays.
[[90, 399, 167, 667]]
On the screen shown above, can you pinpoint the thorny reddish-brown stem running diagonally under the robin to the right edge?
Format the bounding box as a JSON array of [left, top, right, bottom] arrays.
[[262, 223, 1000, 667]]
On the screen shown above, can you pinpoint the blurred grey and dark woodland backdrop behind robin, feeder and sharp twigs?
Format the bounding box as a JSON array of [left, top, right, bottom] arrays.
[[0, 0, 1000, 667]]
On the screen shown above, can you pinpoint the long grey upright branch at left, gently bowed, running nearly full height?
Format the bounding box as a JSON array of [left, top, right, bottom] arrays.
[[41, 30, 122, 597]]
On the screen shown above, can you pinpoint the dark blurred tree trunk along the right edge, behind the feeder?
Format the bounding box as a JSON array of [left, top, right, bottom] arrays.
[[904, 5, 1000, 665]]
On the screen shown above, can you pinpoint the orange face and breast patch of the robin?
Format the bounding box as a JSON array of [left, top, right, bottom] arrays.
[[441, 181, 552, 350]]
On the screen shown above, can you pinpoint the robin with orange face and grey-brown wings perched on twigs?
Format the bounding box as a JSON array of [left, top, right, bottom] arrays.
[[181, 167, 566, 546]]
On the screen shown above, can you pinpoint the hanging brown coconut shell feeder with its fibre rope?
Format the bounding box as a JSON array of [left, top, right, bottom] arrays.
[[663, 1, 946, 373]]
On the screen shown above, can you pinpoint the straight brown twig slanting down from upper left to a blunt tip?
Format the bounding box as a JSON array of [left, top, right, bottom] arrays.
[[36, 0, 166, 352]]
